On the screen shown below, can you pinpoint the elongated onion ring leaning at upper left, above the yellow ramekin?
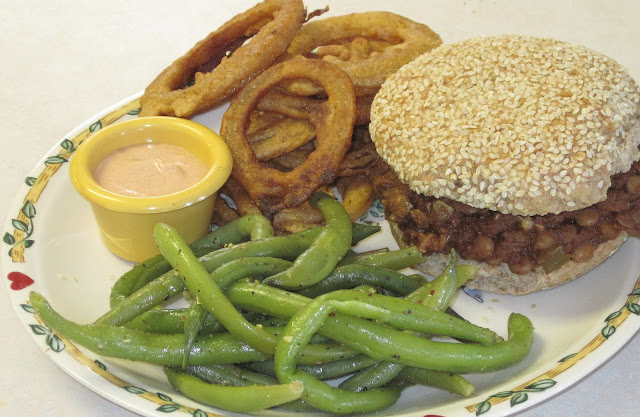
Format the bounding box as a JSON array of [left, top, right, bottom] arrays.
[[140, 0, 306, 117]]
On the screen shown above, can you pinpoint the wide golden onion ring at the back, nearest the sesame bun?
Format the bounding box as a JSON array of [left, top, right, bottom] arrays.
[[284, 12, 442, 96]]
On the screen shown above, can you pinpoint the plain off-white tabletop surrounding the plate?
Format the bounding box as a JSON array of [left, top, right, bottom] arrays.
[[0, 0, 640, 417]]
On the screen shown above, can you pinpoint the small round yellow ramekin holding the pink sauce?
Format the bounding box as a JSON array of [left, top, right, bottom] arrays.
[[69, 116, 232, 262]]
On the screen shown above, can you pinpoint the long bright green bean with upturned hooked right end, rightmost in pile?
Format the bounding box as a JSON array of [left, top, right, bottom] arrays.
[[222, 282, 533, 373]]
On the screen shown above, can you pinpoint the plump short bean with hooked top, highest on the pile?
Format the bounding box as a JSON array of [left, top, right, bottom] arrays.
[[265, 193, 351, 289]]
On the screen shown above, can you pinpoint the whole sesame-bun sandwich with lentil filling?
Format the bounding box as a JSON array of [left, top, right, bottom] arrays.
[[369, 35, 640, 295]]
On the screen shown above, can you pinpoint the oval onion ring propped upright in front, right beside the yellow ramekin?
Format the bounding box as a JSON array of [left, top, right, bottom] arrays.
[[220, 59, 356, 213]]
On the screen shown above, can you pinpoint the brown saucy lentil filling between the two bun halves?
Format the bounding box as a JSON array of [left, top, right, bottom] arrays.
[[373, 154, 640, 275]]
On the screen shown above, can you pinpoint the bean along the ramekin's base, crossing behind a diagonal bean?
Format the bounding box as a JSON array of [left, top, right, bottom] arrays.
[[110, 214, 273, 307]]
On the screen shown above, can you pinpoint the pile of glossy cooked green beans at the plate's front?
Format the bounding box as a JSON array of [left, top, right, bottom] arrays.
[[30, 193, 533, 414]]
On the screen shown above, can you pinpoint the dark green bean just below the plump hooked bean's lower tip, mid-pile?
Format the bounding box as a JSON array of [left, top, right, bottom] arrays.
[[298, 264, 425, 298]]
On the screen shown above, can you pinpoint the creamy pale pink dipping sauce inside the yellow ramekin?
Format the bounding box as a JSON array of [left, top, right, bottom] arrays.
[[94, 142, 208, 197]]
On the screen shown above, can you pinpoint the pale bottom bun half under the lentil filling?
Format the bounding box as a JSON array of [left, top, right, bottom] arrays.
[[389, 222, 628, 295]]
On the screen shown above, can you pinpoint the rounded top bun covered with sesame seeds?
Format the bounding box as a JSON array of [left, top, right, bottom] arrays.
[[370, 35, 640, 216]]
